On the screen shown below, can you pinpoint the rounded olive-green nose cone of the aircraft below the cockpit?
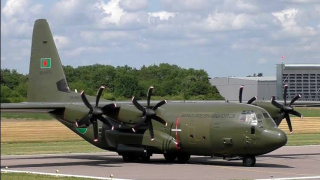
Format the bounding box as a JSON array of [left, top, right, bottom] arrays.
[[264, 129, 287, 150]]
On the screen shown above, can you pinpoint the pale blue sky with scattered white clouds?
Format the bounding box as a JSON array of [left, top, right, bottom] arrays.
[[1, 0, 320, 78]]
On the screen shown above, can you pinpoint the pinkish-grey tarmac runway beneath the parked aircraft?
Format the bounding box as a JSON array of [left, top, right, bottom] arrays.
[[1, 146, 320, 180]]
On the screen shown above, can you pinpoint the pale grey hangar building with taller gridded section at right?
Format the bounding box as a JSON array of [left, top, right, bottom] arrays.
[[210, 64, 320, 102]]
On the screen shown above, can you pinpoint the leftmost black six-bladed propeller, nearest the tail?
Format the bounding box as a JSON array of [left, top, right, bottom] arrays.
[[75, 86, 116, 142]]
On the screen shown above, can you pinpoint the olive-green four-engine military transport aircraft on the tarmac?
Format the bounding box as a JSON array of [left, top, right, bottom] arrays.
[[1, 19, 287, 166]]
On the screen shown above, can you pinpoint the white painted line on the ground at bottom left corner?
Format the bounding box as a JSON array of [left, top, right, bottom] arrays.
[[1, 169, 130, 180]]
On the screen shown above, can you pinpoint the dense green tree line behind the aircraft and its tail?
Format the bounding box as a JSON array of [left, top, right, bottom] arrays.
[[1, 63, 223, 103]]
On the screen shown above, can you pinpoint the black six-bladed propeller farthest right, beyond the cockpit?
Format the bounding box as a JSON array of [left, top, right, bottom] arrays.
[[271, 85, 302, 133]]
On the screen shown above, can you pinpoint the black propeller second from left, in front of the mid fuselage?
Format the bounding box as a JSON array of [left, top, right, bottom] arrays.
[[132, 86, 167, 141]]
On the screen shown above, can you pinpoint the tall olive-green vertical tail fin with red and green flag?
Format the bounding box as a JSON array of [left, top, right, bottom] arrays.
[[27, 19, 70, 102]]
